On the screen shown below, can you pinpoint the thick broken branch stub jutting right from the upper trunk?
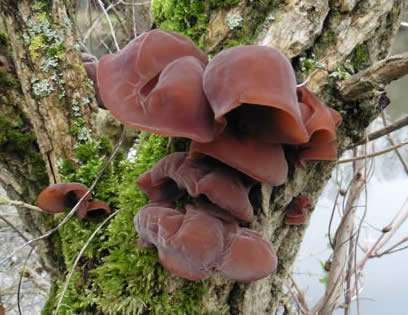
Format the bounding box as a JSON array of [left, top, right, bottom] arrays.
[[337, 54, 408, 100]]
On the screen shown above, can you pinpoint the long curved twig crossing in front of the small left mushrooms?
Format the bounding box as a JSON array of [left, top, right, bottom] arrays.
[[0, 127, 126, 264]]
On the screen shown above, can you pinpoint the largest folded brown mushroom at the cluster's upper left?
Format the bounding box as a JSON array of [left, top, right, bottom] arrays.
[[97, 30, 219, 142]]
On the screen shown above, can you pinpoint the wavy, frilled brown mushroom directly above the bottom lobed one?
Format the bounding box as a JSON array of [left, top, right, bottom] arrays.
[[137, 152, 254, 222]]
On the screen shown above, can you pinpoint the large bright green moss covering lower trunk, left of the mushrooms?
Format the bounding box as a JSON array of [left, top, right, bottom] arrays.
[[46, 133, 217, 314]]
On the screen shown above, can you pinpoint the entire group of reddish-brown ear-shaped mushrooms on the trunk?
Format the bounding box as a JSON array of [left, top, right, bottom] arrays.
[[38, 30, 341, 282]]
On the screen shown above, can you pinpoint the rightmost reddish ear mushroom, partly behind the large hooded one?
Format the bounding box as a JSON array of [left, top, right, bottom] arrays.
[[297, 86, 342, 162]]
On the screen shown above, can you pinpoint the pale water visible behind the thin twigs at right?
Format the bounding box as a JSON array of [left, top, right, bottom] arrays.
[[294, 27, 408, 315]]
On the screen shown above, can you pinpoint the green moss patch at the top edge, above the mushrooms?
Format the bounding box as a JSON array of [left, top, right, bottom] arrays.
[[152, 0, 209, 44]]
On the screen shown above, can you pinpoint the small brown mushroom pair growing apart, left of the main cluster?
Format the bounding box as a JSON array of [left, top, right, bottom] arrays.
[[37, 183, 110, 220]]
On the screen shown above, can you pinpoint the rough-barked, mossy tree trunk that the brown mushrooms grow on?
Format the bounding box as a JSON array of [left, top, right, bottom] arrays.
[[0, 0, 408, 315]]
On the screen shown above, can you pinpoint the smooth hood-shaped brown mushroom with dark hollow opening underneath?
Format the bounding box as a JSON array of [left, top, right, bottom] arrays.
[[203, 45, 309, 144]]
